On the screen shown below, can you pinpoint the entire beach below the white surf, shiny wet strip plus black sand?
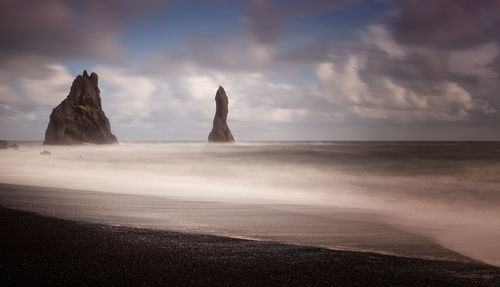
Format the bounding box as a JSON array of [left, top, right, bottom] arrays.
[[0, 184, 500, 286]]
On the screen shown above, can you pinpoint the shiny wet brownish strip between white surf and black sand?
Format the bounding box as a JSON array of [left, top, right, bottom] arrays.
[[0, 184, 471, 262]]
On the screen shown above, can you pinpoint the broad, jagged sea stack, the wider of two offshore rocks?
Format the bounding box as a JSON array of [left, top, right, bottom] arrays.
[[44, 71, 118, 145]]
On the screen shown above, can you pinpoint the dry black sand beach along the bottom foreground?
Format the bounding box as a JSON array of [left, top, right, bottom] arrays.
[[0, 208, 500, 286]]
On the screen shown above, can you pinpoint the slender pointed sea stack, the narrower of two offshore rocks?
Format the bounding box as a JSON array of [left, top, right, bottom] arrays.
[[208, 86, 234, 142]]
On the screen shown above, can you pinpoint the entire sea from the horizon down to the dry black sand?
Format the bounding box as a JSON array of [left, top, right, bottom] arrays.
[[0, 142, 500, 266]]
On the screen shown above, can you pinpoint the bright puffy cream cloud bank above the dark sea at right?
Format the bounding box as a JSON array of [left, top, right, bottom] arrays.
[[313, 55, 495, 121]]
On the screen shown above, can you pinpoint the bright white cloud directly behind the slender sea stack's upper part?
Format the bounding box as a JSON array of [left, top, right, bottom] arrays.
[[180, 67, 307, 123]]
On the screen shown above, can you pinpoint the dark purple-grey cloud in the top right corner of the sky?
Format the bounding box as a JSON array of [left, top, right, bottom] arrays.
[[392, 0, 500, 50]]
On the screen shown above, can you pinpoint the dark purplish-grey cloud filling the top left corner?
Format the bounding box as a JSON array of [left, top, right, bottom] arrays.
[[0, 0, 168, 59]]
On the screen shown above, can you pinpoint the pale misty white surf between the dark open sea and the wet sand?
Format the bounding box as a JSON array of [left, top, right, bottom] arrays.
[[0, 143, 500, 266]]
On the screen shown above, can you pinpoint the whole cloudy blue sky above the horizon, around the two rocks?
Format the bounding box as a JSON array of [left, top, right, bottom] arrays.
[[0, 0, 500, 141]]
